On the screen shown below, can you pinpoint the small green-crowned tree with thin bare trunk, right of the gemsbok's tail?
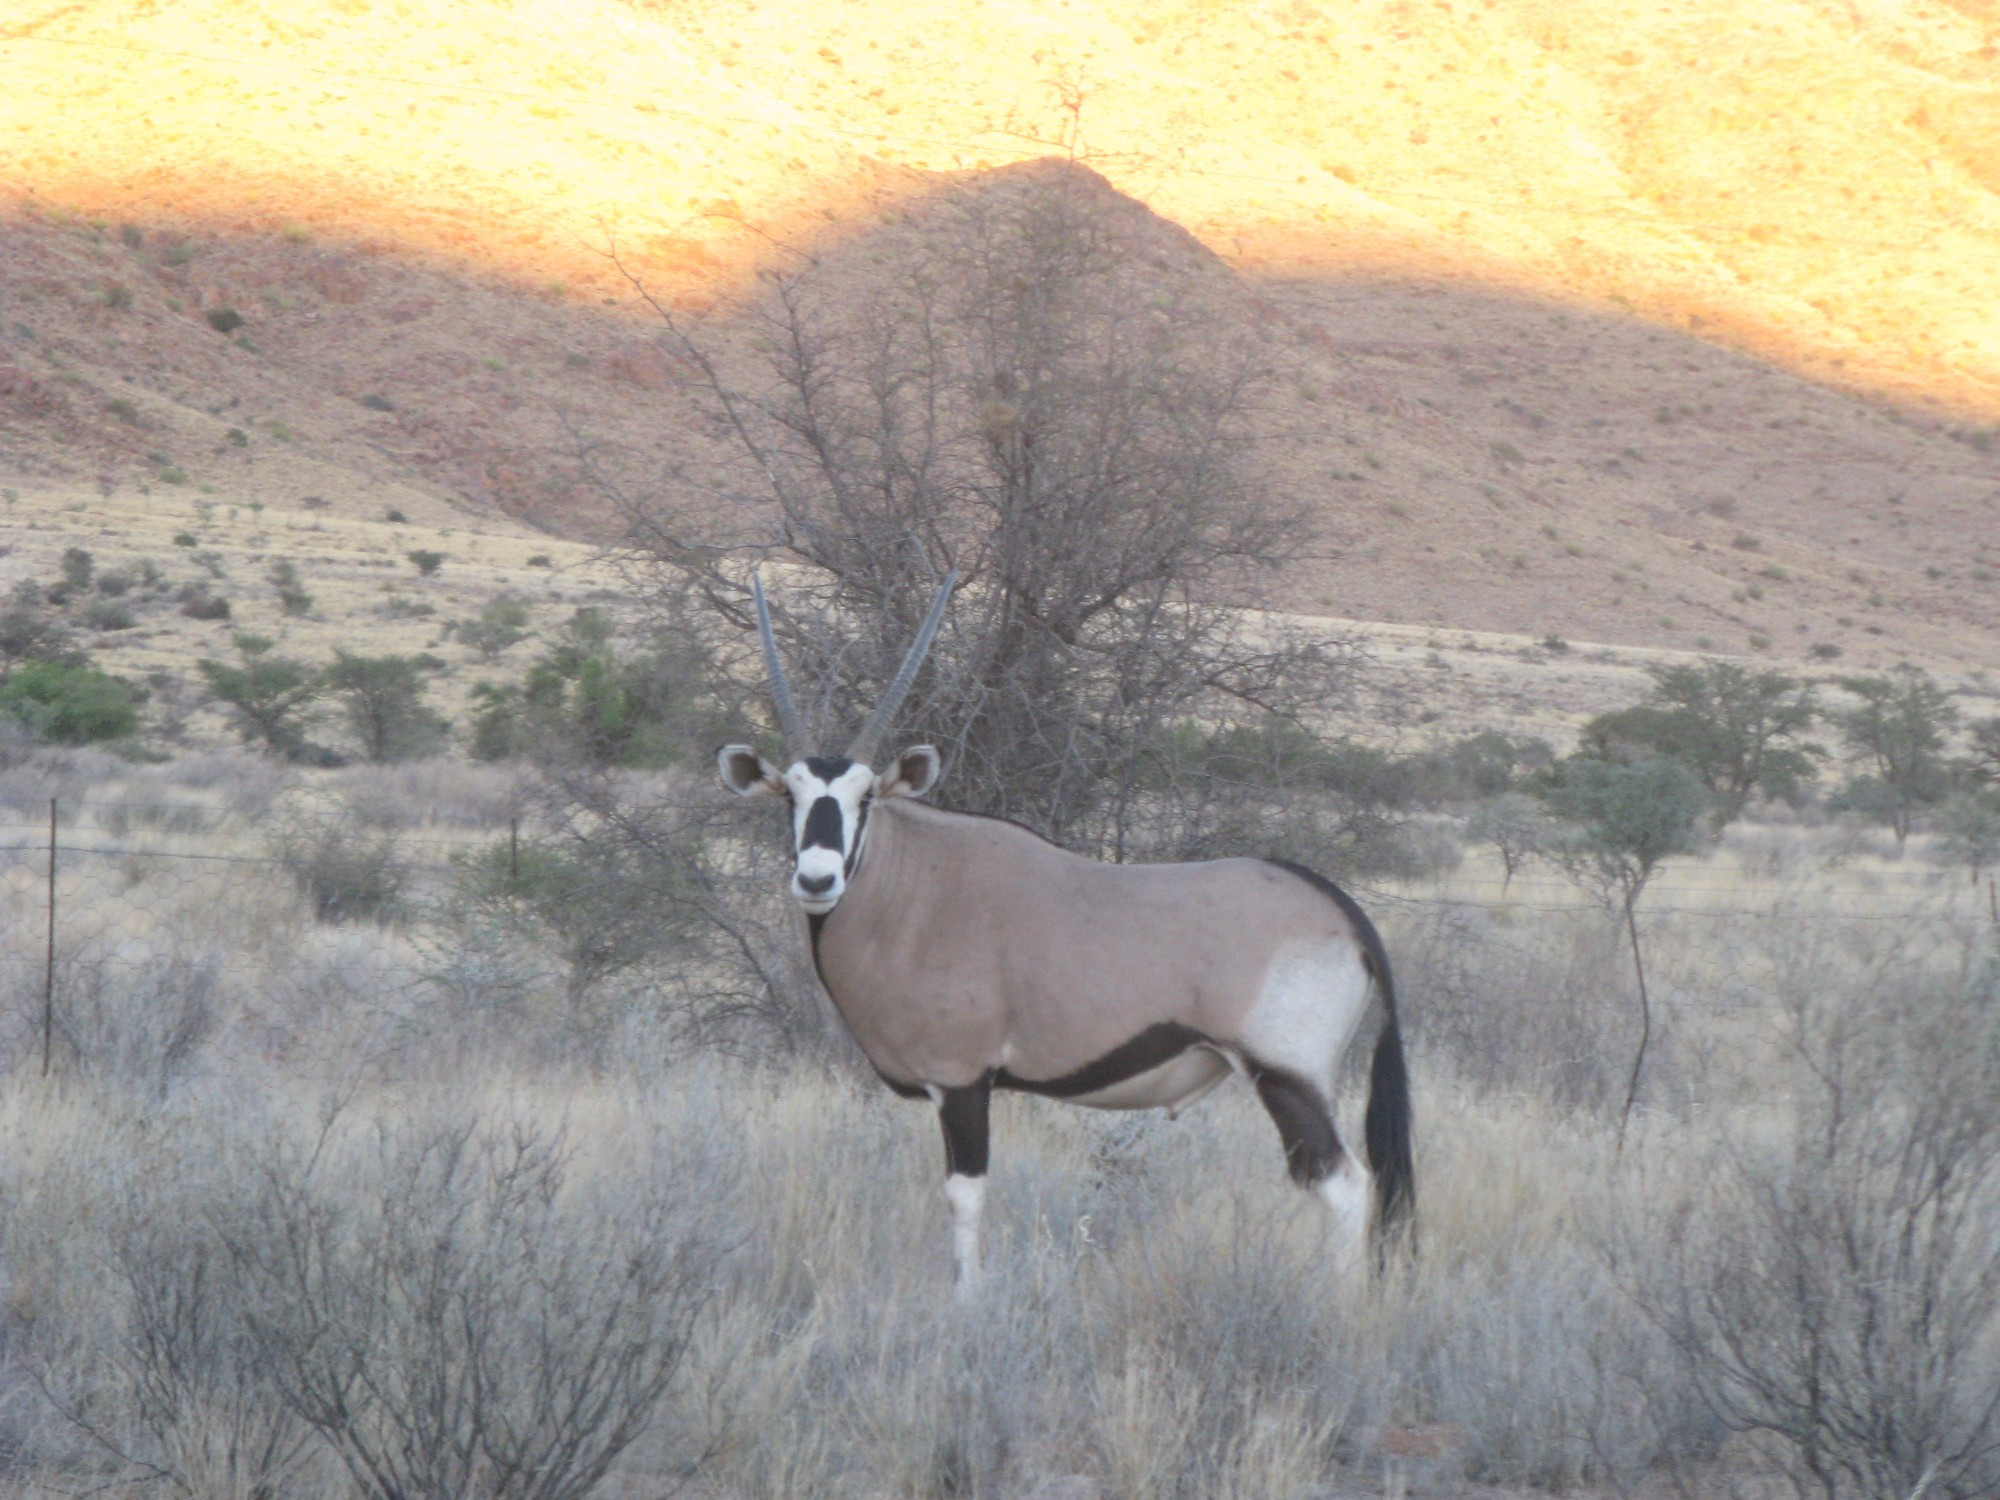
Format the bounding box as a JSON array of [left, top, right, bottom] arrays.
[[1544, 756, 1708, 1150]]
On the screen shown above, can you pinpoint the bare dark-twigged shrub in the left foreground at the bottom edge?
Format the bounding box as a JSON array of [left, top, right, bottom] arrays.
[[224, 1124, 714, 1500]]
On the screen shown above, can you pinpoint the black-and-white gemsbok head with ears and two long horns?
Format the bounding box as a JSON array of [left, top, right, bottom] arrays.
[[716, 570, 958, 916]]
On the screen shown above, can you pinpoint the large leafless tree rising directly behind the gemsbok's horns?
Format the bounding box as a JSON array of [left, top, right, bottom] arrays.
[[608, 164, 1354, 856]]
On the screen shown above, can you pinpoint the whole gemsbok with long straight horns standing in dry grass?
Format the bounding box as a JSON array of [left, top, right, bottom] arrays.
[[716, 574, 1416, 1294]]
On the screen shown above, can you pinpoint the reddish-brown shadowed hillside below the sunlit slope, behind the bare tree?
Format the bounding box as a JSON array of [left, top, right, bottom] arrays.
[[0, 168, 2000, 666]]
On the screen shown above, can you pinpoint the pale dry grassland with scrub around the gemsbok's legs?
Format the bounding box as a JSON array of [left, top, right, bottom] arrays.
[[0, 750, 2000, 1498]]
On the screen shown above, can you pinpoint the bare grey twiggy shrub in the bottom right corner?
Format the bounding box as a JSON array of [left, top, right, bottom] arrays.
[[1628, 968, 2000, 1500]]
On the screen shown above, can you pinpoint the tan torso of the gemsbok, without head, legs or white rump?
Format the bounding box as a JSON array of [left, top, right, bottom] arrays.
[[816, 798, 1364, 1108]]
